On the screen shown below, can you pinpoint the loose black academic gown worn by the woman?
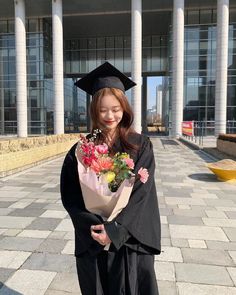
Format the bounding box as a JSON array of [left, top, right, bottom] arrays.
[[61, 133, 161, 295]]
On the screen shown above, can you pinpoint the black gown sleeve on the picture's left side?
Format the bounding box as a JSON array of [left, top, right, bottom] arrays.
[[60, 145, 103, 255]]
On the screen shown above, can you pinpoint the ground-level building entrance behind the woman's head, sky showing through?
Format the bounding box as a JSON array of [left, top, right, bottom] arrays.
[[68, 74, 169, 134]]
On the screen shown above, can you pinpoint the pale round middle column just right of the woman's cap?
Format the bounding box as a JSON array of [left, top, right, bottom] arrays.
[[131, 0, 142, 133]]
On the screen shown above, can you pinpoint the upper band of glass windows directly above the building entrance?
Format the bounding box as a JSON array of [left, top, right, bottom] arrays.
[[65, 35, 167, 75]]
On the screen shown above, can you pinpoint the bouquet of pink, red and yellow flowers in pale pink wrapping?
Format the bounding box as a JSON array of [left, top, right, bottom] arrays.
[[76, 130, 149, 221]]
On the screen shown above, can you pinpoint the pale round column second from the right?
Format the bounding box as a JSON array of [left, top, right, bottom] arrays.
[[171, 0, 184, 138]]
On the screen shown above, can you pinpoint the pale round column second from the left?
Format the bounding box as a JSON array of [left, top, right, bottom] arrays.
[[52, 0, 64, 134]]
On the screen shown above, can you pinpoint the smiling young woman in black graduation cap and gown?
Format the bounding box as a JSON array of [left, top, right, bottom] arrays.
[[61, 63, 161, 295]]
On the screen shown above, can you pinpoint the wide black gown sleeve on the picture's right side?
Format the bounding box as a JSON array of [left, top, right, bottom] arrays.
[[108, 136, 161, 254]]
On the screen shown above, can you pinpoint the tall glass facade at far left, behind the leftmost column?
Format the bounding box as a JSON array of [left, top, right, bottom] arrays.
[[0, 19, 53, 134]]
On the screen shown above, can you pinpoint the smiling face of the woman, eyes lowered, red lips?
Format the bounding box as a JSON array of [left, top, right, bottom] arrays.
[[99, 94, 123, 131]]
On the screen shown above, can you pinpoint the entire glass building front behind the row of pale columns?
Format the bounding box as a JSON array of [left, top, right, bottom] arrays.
[[0, 5, 236, 135]]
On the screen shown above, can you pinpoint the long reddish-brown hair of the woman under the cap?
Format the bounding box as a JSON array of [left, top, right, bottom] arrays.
[[90, 88, 138, 152]]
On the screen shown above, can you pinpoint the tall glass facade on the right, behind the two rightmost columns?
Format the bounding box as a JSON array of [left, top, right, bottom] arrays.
[[169, 9, 236, 135]]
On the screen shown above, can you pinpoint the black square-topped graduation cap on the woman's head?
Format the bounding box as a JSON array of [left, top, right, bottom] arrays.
[[75, 62, 136, 95]]
